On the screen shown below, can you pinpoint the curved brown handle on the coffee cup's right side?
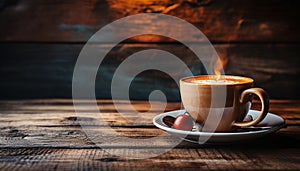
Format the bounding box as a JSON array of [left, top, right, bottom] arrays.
[[233, 88, 269, 127]]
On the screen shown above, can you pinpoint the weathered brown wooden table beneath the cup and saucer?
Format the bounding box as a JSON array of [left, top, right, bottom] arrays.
[[0, 99, 300, 170]]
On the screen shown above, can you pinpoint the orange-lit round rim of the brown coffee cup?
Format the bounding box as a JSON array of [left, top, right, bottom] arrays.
[[180, 75, 254, 86]]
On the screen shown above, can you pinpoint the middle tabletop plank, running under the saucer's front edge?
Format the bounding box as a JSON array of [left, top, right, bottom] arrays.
[[0, 123, 300, 149]]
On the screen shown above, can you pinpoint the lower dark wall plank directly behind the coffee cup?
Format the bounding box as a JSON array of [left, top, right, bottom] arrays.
[[0, 43, 300, 101]]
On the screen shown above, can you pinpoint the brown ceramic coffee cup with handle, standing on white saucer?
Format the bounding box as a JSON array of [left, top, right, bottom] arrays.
[[180, 75, 269, 132]]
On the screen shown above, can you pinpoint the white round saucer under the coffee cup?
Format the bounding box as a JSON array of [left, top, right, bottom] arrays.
[[153, 110, 285, 144]]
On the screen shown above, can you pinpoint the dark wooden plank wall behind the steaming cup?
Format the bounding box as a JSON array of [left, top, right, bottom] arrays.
[[0, 0, 300, 101]]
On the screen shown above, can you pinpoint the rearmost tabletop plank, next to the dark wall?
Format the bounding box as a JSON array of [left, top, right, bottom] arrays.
[[0, 99, 300, 127]]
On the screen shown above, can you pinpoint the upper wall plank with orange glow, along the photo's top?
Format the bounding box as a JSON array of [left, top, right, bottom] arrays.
[[0, 0, 300, 42]]
